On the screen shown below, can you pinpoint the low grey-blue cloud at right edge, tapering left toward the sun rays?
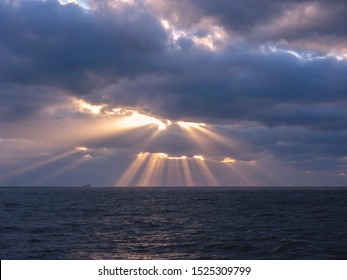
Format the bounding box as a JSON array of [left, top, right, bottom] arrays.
[[228, 125, 347, 162]]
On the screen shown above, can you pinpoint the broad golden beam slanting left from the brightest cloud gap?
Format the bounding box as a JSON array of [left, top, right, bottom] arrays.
[[38, 106, 171, 147]]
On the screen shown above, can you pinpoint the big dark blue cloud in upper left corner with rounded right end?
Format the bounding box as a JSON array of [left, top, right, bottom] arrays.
[[0, 0, 166, 91]]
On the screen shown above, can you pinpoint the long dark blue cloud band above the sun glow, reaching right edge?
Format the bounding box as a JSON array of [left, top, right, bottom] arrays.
[[100, 47, 347, 130]]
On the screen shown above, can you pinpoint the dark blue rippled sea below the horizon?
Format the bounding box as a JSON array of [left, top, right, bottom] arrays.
[[0, 188, 347, 259]]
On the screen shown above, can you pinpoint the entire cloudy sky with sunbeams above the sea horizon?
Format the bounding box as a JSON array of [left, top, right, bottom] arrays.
[[0, 0, 347, 186]]
